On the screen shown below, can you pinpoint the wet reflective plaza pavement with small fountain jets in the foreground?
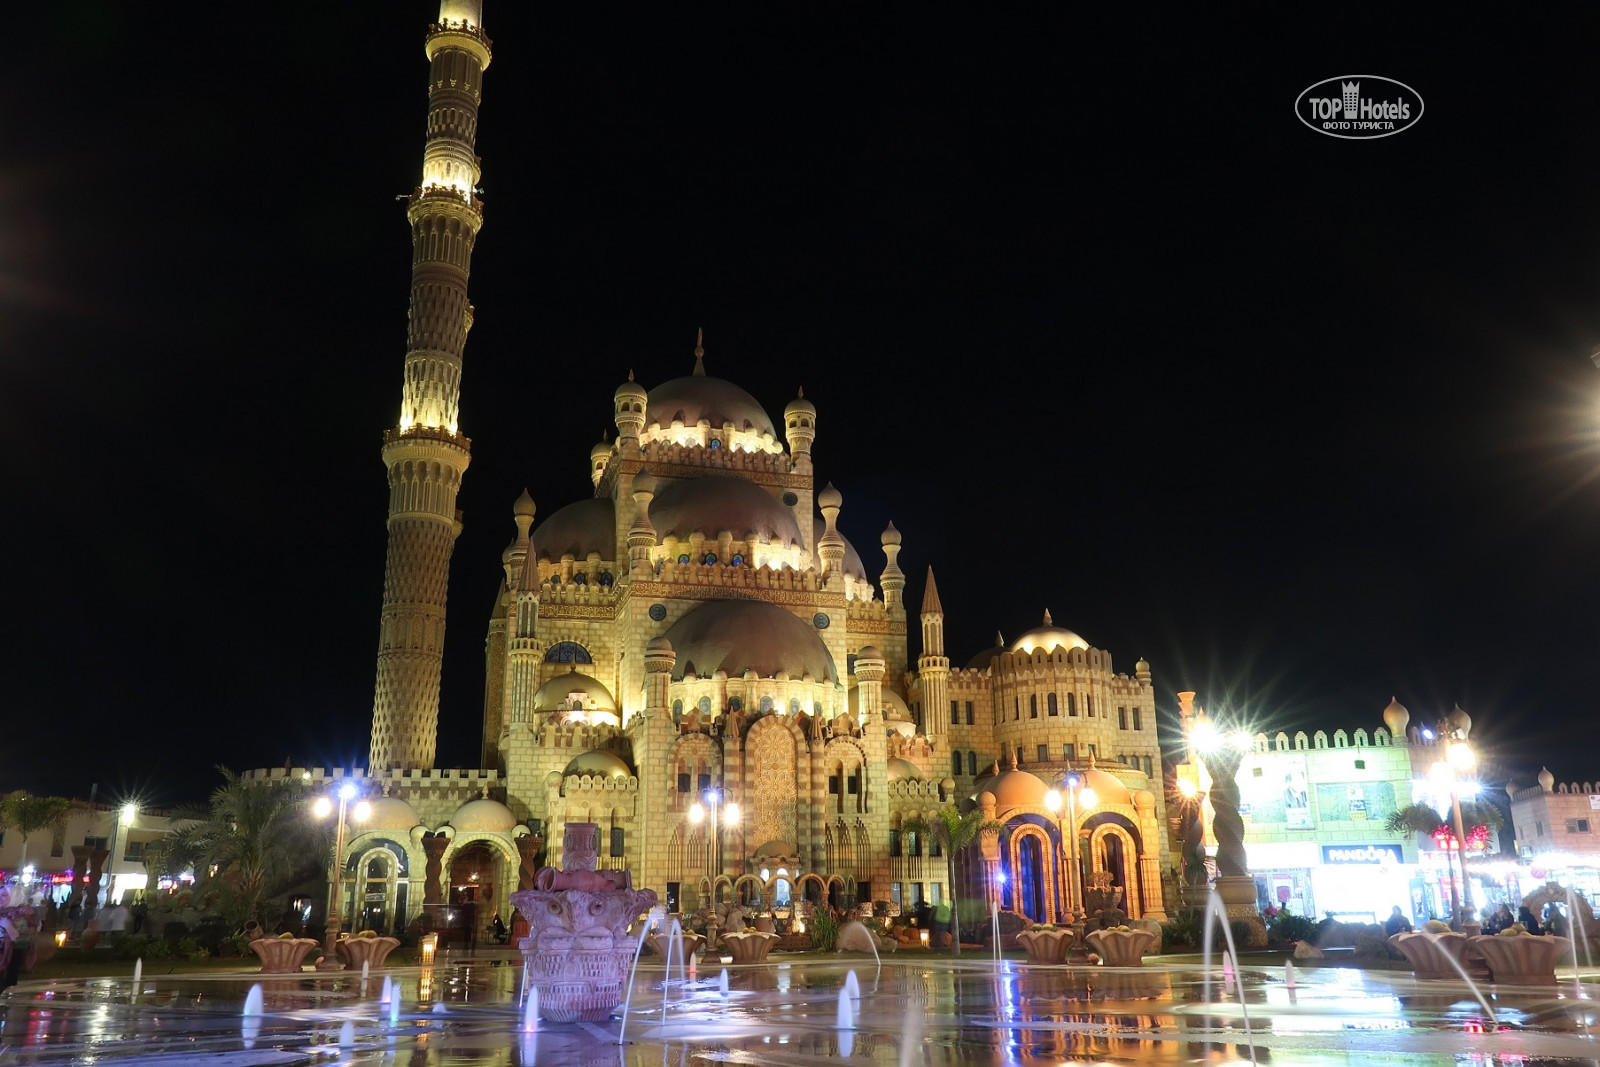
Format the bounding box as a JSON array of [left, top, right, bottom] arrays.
[[0, 957, 1600, 1067]]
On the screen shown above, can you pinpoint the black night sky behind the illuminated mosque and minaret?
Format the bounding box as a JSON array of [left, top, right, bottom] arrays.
[[0, 0, 1600, 800]]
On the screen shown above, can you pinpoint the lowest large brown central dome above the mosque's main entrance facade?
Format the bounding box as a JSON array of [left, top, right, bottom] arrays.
[[666, 600, 838, 681]]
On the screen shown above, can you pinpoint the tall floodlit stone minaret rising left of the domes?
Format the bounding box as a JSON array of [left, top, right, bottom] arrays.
[[368, 0, 490, 771]]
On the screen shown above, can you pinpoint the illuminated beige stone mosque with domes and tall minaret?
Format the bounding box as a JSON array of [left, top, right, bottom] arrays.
[[254, 0, 1174, 929]]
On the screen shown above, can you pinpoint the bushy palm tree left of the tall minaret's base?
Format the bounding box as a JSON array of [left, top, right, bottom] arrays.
[[163, 766, 330, 923]]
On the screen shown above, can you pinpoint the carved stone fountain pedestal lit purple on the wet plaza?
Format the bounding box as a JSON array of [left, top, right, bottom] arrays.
[[510, 822, 656, 1022]]
